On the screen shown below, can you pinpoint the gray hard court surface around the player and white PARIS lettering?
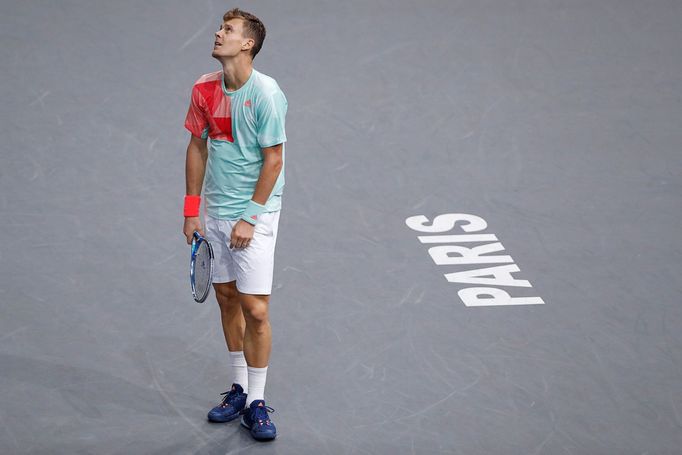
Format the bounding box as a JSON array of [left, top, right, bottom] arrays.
[[0, 0, 682, 455]]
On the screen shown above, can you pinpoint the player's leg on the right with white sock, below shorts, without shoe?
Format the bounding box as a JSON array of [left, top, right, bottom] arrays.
[[239, 293, 272, 403]]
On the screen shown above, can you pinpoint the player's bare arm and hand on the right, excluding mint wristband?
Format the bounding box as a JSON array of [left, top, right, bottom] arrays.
[[230, 144, 283, 248]]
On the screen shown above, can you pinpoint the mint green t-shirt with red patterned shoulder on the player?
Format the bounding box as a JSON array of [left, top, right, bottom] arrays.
[[185, 69, 287, 220]]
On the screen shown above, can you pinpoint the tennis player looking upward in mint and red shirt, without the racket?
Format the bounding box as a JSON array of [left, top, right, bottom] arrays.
[[183, 8, 287, 440]]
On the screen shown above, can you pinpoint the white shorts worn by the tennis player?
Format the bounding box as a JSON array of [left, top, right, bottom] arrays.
[[205, 210, 280, 295]]
